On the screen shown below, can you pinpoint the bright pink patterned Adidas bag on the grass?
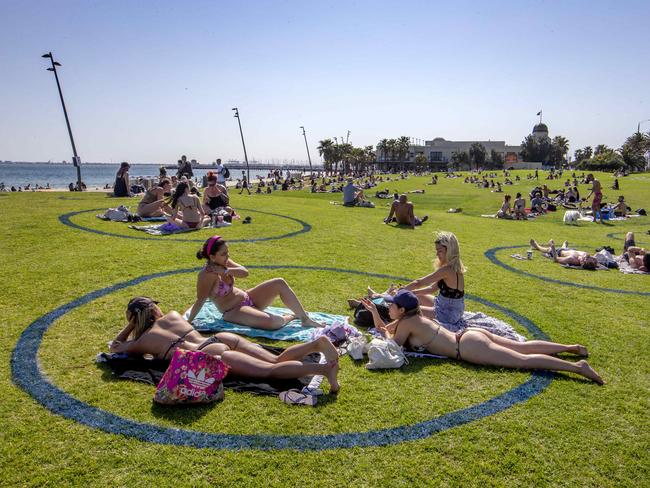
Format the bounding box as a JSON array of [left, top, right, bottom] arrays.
[[153, 349, 228, 405]]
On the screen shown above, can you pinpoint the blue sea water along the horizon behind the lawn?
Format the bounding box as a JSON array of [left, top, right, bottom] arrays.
[[0, 163, 300, 190]]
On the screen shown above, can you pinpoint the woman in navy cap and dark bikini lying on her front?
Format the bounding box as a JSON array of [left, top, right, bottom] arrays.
[[362, 290, 604, 385]]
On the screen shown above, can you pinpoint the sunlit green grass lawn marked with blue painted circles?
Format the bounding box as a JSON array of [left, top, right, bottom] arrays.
[[0, 171, 650, 486]]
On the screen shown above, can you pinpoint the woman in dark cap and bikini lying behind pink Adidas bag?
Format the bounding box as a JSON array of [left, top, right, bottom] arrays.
[[110, 297, 340, 393]]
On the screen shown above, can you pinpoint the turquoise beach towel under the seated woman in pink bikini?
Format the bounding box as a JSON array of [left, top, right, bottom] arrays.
[[183, 300, 352, 342]]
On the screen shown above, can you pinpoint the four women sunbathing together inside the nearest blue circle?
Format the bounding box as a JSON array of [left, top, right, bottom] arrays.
[[110, 232, 603, 393]]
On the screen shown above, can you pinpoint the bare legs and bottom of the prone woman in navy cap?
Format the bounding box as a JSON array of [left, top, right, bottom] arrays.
[[460, 331, 604, 385]]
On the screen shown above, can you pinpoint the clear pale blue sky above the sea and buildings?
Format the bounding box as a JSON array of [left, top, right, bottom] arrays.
[[0, 0, 650, 162]]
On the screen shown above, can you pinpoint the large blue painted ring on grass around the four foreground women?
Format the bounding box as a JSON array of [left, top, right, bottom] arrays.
[[11, 265, 554, 451]]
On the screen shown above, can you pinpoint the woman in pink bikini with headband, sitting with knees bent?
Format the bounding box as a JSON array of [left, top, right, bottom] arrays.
[[188, 236, 322, 330]]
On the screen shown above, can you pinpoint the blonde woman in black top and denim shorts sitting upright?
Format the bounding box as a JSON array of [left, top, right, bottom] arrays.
[[403, 231, 467, 324]]
